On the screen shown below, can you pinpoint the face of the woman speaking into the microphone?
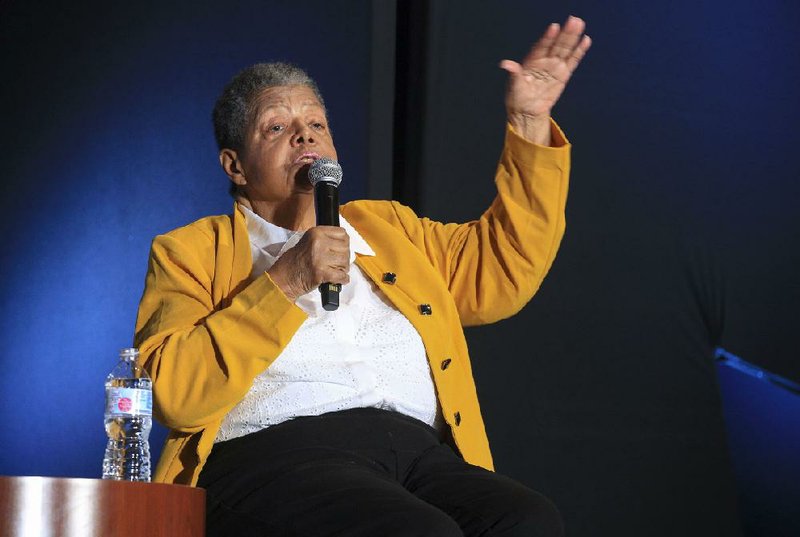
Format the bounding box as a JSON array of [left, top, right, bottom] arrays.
[[238, 86, 336, 202]]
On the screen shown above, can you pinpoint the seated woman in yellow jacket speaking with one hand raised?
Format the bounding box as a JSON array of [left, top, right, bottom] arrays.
[[136, 17, 590, 537]]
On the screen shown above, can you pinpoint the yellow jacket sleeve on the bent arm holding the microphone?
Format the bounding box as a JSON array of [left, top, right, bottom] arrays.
[[135, 217, 306, 432]]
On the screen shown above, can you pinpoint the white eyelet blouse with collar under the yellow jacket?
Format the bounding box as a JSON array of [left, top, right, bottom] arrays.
[[215, 203, 439, 442]]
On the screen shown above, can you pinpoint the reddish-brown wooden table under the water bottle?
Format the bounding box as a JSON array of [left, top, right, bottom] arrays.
[[0, 477, 206, 537]]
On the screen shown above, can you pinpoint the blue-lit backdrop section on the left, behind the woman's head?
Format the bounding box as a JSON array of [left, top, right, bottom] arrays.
[[0, 1, 369, 477]]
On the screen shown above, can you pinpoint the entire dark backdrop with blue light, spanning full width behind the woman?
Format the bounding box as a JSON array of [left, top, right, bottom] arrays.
[[0, 0, 800, 536]]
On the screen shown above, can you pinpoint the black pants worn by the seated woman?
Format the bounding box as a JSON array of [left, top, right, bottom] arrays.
[[198, 408, 563, 537]]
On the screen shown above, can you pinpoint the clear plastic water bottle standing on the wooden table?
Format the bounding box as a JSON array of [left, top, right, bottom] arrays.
[[103, 349, 153, 481]]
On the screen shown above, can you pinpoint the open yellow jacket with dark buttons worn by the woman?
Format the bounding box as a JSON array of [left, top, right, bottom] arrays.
[[135, 124, 570, 485]]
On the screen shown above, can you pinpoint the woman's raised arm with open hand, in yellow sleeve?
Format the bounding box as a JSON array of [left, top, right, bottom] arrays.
[[386, 17, 591, 325]]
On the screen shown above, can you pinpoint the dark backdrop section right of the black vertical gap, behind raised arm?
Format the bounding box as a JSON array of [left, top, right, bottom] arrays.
[[394, 0, 800, 536]]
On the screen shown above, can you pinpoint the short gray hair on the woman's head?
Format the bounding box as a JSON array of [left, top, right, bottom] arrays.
[[213, 62, 325, 151]]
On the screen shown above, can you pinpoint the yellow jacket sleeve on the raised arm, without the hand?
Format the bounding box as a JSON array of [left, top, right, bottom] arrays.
[[376, 123, 571, 326]]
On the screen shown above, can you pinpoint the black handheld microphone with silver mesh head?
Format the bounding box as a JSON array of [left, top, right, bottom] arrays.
[[308, 157, 342, 311]]
